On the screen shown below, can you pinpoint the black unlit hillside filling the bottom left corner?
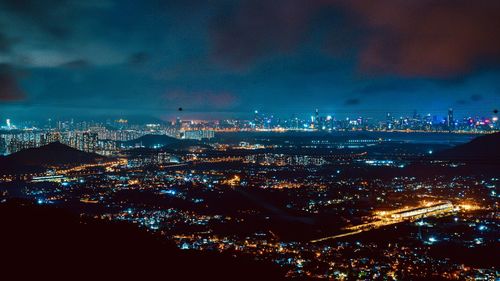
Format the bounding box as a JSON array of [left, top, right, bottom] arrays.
[[0, 200, 284, 280]]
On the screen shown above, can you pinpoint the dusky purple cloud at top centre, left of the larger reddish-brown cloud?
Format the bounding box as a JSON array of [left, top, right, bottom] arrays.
[[211, 0, 318, 66]]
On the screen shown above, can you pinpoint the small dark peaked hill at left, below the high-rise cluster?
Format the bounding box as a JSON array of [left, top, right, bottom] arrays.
[[0, 142, 104, 174]]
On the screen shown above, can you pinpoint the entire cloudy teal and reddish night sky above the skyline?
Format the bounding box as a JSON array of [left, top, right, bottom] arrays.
[[0, 0, 500, 119]]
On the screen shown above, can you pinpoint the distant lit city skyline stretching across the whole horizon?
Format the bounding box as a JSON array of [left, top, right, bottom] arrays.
[[0, 105, 500, 156]]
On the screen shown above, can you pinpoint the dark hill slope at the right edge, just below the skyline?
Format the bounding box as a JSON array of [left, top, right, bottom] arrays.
[[433, 133, 500, 165]]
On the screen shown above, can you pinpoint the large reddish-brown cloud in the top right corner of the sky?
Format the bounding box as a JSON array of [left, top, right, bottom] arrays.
[[349, 0, 500, 78]]
